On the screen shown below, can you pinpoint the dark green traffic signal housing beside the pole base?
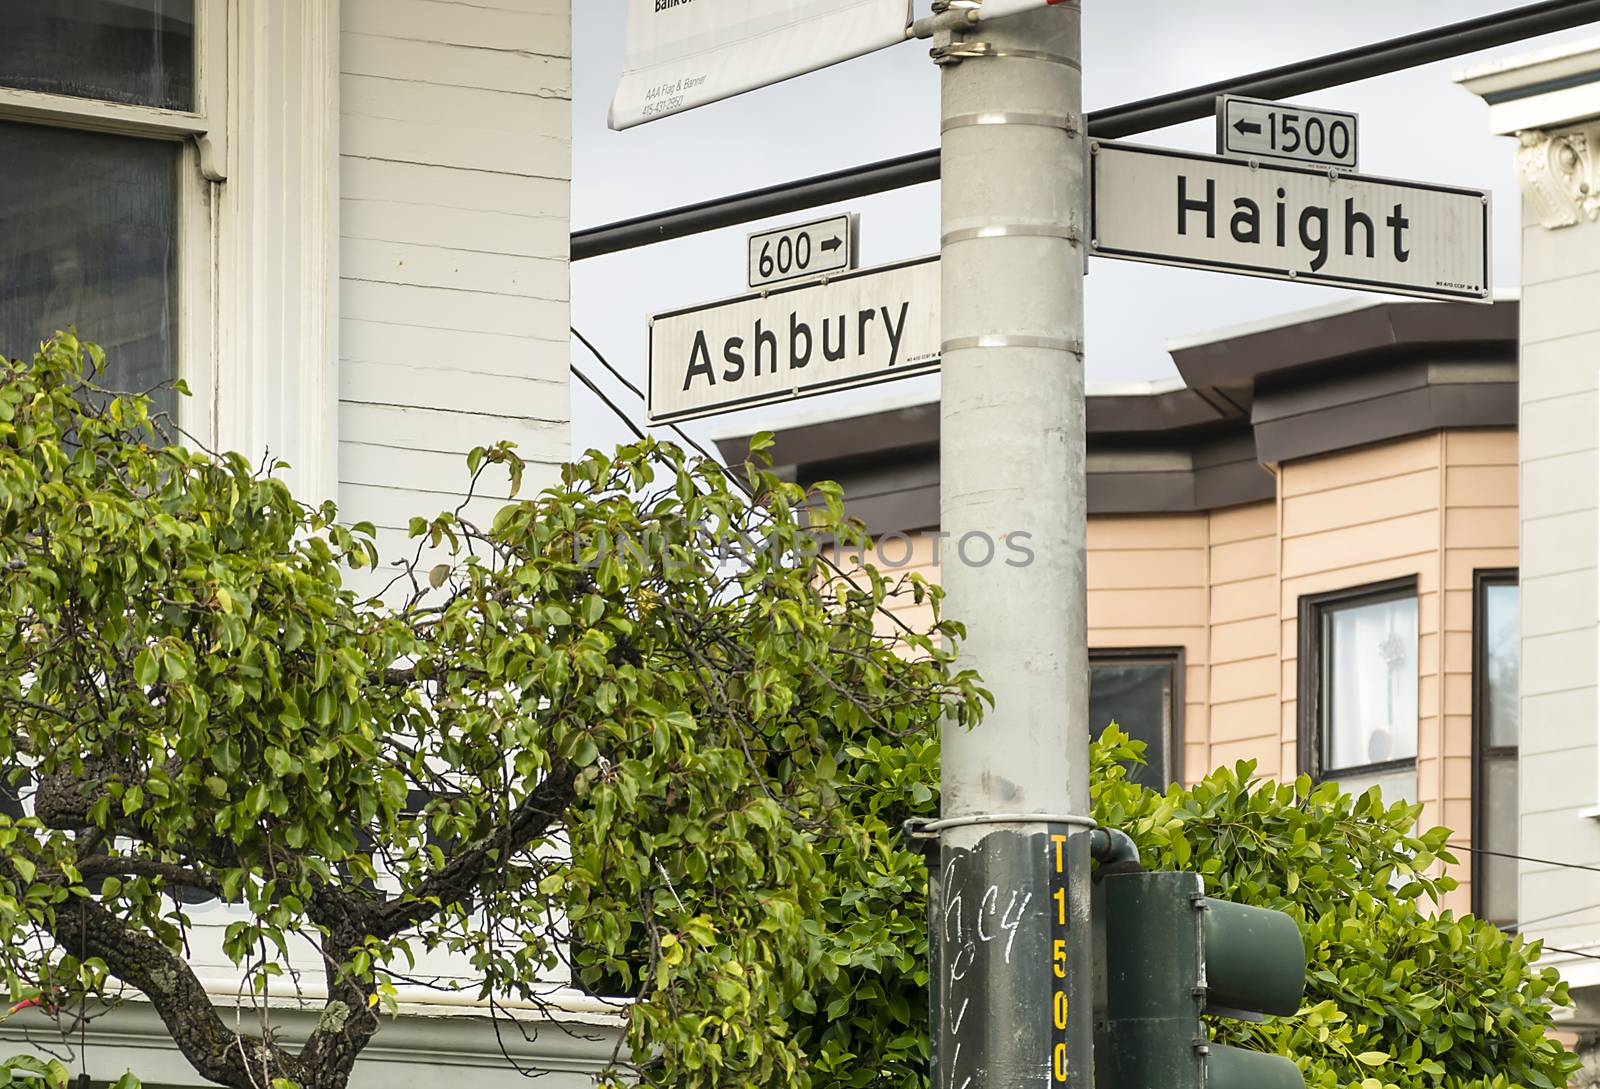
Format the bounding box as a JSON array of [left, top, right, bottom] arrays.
[[1094, 870, 1306, 1089]]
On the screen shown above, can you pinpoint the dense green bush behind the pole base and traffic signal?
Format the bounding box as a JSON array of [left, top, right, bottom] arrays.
[[800, 726, 1579, 1089]]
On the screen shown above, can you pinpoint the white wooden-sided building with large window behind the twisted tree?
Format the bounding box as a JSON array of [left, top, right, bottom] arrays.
[[0, 0, 618, 1089]]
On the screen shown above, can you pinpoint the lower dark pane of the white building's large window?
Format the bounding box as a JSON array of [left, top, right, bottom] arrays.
[[0, 122, 179, 411]]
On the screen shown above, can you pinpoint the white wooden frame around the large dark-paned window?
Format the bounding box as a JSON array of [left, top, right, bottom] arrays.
[[0, 0, 227, 445]]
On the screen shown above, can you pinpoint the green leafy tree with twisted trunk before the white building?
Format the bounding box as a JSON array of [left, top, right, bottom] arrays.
[[0, 334, 984, 1089]]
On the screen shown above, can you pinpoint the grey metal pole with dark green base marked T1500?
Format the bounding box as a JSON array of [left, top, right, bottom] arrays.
[[931, 2, 1093, 1089]]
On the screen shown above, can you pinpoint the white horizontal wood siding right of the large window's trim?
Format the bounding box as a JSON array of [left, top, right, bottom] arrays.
[[339, 0, 571, 582]]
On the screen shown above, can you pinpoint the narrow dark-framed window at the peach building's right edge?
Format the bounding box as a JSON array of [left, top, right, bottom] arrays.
[[1472, 569, 1522, 929]]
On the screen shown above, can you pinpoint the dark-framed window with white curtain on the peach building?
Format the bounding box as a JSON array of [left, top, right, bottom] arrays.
[[1299, 579, 1418, 801]]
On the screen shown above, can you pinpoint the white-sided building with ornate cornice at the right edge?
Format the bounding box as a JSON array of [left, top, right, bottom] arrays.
[[1459, 38, 1600, 1084]]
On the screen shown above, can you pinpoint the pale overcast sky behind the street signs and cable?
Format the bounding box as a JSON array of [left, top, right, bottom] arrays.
[[573, 0, 1600, 451]]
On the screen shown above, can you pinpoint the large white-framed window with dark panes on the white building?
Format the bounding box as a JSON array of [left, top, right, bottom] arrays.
[[0, 0, 226, 430]]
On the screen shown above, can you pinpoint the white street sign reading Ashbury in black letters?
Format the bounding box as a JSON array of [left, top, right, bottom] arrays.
[[650, 257, 939, 424]]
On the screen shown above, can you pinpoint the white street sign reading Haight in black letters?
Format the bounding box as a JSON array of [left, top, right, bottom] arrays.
[[1090, 141, 1490, 302]]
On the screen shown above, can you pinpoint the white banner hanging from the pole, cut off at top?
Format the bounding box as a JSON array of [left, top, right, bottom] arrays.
[[610, 0, 915, 130]]
